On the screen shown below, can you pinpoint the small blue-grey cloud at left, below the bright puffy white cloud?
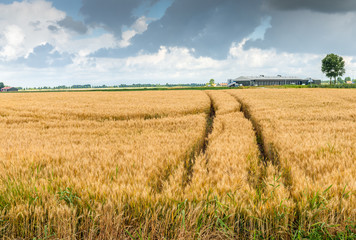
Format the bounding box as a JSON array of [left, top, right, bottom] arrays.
[[17, 43, 72, 68]]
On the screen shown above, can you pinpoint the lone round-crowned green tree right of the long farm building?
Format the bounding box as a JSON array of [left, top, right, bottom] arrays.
[[321, 53, 345, 84]]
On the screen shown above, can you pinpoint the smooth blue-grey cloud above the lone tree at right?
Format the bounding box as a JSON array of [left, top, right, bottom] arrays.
[[245, 10, 356, 55]]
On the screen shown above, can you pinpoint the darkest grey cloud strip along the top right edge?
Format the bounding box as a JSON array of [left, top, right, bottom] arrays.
[[266, 0, 356, 13]]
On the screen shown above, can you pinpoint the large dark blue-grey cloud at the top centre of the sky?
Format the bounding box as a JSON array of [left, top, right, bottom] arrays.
[[88, 0, 263, 58]]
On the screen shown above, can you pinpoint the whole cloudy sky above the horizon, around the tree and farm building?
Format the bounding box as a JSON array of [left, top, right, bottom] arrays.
[[0, 0, 356, 87]]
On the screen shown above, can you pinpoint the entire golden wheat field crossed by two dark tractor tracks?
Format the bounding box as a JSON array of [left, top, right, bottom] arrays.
[[0, 89, 356, 239]]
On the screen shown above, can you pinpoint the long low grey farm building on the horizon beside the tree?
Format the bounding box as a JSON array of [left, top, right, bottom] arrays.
[[228, 75, 321, 87]]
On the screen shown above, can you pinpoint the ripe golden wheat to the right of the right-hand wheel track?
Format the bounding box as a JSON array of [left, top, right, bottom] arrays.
[[231, 89, 356, 229]]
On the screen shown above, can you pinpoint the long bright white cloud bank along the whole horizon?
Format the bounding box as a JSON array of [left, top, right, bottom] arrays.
[[0, 33, 356, 86]]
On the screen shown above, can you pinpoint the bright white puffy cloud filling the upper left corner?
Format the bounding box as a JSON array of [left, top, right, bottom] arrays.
[[0, 0, 68, 61]]
